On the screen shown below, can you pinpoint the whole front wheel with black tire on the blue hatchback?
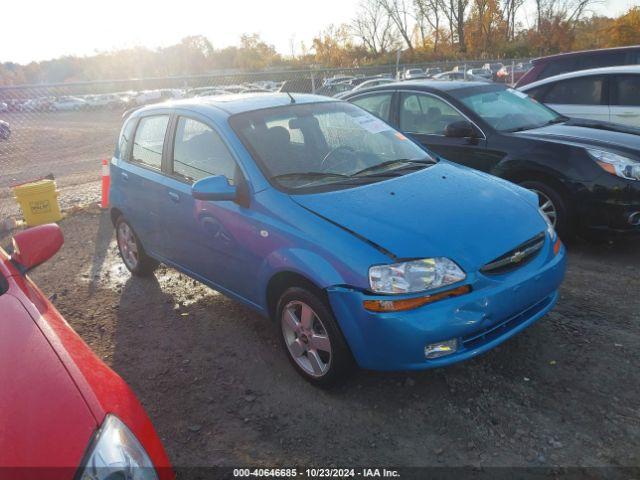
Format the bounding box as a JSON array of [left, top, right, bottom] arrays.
[[276, 287, 354, 387]]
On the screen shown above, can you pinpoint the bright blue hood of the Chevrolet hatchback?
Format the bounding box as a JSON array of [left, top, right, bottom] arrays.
[[292, 161, 546, 272]]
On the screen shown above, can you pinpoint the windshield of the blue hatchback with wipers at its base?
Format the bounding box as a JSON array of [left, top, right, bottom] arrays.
[[230, 102, 434, 193]]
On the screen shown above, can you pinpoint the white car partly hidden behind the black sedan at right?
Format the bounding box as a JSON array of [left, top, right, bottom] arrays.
[[519, 65, 640, 127]]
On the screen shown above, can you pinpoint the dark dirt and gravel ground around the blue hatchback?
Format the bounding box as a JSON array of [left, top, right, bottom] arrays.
[[18, 210, 640, 470]]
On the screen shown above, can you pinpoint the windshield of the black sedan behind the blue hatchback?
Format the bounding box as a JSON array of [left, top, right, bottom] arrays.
[[460, 88, 566, 132]]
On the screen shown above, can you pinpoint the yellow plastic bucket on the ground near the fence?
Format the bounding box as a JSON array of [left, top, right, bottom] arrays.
[[13, 180, 62, 227]]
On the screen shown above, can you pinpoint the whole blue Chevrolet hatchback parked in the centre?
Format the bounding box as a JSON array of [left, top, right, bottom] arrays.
[[110, 94, 565, 385]]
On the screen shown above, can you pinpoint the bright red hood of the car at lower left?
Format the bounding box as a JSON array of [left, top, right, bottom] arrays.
[[0, 293, 97, 466]]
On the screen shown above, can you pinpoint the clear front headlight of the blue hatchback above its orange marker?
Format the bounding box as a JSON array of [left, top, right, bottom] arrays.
[[369, 257, 466, 293]]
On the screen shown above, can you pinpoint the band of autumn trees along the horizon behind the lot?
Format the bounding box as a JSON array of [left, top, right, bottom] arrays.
[[0, 0, 640, 85]]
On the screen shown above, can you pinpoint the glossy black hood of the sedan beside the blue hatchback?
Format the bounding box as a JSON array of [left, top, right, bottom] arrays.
[[515, 118, 640, 157]]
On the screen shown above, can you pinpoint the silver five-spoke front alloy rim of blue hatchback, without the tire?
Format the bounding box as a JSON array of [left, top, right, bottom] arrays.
[[281, 300, 332, 378]]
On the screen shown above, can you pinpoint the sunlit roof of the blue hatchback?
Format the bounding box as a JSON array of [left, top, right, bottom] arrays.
[[135, 92, 335, 116]]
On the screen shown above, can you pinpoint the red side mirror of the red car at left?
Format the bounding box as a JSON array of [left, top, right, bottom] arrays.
[[11, 223, 64, 271]]
